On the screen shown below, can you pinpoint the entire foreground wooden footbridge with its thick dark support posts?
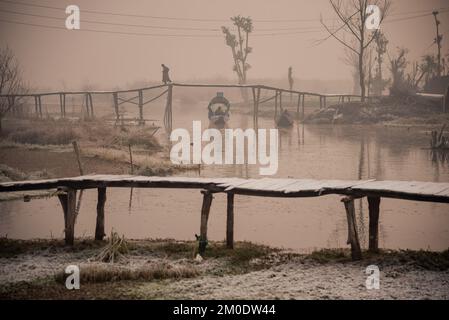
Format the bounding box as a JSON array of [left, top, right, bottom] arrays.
[[0, 175, 449, 259]]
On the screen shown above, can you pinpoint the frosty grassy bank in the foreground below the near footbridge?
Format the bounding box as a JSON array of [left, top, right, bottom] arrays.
[[0, 239, 449, 299]]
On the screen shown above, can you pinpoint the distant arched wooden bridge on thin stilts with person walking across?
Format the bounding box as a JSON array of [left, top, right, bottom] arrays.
[[0, 83, 360, 132]]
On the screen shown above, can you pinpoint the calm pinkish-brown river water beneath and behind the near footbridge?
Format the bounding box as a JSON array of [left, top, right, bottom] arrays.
[[0, 108, 449, 250]]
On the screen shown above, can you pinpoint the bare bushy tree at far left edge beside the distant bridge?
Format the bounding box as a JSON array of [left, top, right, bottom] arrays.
[[0, 47, 24, 134]]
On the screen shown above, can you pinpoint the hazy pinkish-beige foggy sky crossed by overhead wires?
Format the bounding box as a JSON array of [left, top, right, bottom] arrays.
[[0, 0, 449, 89]]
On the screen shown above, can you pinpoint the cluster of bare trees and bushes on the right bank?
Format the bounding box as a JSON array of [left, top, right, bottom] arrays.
[[322, 0, 449, 101]]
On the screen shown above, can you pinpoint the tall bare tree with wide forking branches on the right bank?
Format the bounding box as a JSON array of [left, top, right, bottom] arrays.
[[321, 0, 390, 101]]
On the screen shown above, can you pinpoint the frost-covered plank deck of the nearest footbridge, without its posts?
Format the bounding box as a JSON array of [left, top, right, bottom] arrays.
[[0, 175, 449, 203]]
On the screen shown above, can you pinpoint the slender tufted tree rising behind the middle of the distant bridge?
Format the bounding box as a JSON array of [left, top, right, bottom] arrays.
[[221, 16, 253, 100]]
